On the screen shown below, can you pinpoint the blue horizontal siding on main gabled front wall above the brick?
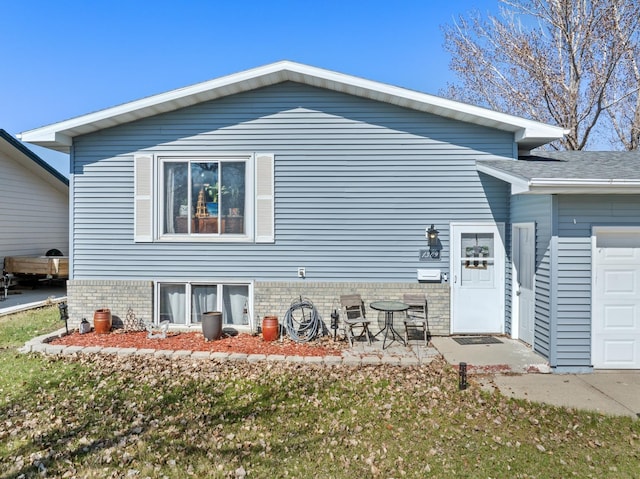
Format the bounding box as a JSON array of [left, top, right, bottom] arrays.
[[72, 82, 514, 282]]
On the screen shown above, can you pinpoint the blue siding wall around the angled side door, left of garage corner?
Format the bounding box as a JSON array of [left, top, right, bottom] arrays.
[[511, 195, 553, 359]]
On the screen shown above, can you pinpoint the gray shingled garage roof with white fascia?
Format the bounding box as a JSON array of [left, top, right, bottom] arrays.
[[476, 151, 640, 194]]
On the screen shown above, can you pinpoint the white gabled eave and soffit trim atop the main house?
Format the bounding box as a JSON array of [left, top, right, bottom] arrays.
[[21, 61, 565, 153]]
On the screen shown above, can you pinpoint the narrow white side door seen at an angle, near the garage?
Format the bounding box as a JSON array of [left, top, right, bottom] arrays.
[[511, 223, 536, 346]]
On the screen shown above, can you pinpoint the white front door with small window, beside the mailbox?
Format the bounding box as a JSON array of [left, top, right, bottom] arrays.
[[451, 223, 505, 334]]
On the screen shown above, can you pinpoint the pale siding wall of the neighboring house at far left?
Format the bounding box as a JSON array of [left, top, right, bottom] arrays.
[[0, 152, 69, 262]]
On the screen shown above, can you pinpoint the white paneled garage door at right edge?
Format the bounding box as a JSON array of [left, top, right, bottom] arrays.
[[591, 229, 640, 369]]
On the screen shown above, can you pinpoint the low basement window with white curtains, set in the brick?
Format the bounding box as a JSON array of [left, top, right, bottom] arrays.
[[156, 283, 251, 327]]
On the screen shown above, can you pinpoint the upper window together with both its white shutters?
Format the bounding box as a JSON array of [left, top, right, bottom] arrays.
[[134, 153, 275, 243]]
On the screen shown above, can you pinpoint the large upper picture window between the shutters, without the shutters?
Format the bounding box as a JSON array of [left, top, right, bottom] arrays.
[[161, 158, 247, 236]]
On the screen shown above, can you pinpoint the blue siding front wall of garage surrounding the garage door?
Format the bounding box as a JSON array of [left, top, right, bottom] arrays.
[[556, 195, 640, 368]]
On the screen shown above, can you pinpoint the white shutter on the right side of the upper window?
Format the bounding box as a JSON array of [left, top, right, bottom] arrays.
[[256, 153, 275, 243]]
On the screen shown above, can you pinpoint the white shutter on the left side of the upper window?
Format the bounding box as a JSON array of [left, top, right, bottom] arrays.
[[133, 154, 153, 243]]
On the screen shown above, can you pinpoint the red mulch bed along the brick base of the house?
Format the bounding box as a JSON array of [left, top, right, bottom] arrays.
[[51, 330, 346, 356]]
